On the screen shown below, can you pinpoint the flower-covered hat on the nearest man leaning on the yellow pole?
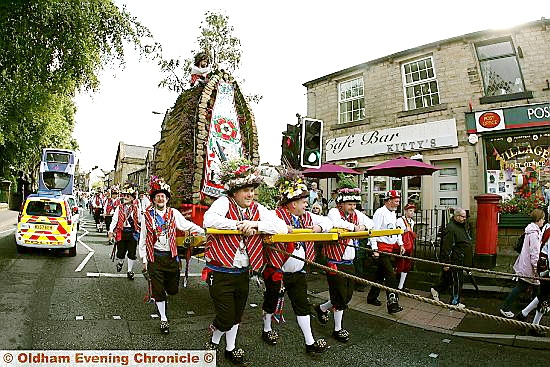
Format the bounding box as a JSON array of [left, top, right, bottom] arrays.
[[220, 158, 263, 194]]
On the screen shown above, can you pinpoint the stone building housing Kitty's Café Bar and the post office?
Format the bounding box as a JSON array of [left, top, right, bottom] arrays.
[[304, 18, 550, 217]]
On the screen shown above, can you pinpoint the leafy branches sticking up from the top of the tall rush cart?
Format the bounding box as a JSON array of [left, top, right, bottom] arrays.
[[159, 11, 242, 93]]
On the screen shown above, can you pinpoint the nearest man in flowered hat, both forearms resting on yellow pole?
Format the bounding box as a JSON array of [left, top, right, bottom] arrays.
[[203, 158, 288, 364]]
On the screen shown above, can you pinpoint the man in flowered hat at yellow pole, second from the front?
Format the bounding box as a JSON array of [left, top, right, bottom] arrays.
[[262, 170, 332, 353]]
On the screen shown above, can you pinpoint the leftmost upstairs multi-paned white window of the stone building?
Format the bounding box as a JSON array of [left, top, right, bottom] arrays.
[[338, 77, 365, 124]]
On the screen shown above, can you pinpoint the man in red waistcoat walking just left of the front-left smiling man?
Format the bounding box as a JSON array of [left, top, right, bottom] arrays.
[[107, 186, 140, 280]]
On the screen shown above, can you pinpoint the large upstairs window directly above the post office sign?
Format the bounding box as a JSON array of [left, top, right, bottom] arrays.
[[476, 39, 525, 96]]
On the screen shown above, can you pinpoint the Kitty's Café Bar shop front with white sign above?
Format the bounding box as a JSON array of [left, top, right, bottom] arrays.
[[325, 119, 467, 212]]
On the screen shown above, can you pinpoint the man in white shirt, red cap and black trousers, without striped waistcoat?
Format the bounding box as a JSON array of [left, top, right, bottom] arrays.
[[367, 190, 405, 313]]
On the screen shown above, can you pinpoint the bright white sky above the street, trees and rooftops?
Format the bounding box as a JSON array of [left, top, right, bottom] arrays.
[[73, 0, 550, 171]]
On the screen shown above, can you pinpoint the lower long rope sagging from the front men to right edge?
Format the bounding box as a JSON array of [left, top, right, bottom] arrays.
[[264, 244, 550, 332]]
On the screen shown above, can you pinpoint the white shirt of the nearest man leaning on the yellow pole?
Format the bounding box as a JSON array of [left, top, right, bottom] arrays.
[[203, 196, 288, 268]]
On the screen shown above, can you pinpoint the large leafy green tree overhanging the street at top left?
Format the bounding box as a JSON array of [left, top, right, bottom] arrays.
[[0, 0, 161, 176]]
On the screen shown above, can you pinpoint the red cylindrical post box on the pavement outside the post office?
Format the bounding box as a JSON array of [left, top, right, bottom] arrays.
[[474, 194, 502, 269]]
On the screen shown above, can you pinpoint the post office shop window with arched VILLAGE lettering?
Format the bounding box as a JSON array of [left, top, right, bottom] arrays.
[[483, 131, 550, 200]]
